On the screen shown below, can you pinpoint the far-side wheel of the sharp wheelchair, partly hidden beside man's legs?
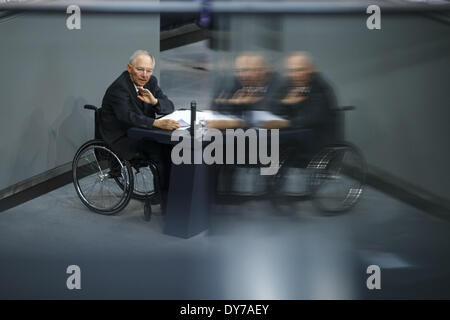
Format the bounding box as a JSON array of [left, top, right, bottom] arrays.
[[114, 165, 156, 200]]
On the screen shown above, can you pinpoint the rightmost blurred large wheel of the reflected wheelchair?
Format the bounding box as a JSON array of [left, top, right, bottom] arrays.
[[307, 143, 367, 213]]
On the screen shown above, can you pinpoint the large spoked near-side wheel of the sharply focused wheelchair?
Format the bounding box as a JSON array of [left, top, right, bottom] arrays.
[[72, 140, 134, 215]]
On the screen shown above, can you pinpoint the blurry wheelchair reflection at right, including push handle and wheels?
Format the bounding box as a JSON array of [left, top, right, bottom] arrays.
[[216, 107, 367, 213]]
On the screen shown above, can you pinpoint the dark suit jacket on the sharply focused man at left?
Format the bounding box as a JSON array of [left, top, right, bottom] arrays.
[[100, 71, 174, 145]]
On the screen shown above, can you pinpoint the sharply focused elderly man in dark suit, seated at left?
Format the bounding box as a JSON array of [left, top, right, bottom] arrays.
[[101, 50, 179, 205]]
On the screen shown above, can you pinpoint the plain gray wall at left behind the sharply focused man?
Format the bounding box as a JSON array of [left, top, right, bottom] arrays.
[[0, 13, 159, 190]]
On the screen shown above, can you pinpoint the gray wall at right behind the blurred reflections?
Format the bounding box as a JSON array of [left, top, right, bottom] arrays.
[[283, 14, 450, 200]]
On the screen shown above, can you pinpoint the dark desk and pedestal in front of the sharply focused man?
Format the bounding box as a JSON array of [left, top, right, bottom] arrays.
[[127, 128, 213, 238]]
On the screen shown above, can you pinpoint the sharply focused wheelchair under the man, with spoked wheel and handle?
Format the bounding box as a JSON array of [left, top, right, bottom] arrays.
[[72, 105, 159, 220]]
